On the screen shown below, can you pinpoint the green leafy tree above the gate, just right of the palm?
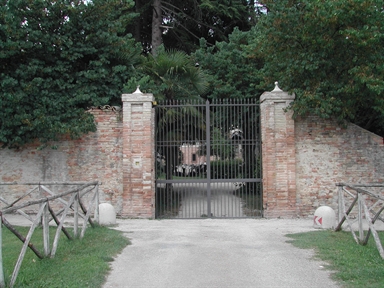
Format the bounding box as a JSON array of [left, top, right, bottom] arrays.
[[192, 29, 264, 99]]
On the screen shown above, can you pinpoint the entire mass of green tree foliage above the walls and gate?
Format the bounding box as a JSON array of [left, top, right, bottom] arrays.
[[0, 0, 384, 147]]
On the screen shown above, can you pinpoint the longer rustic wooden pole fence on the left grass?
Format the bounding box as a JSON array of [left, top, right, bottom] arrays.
[[0, 181, 101, 288]]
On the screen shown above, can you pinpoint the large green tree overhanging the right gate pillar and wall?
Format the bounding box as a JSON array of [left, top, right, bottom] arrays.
[[253, 0, 384, 135]]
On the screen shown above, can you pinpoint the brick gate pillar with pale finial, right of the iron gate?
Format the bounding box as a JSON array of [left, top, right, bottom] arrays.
[[260, 82, 296, 218]]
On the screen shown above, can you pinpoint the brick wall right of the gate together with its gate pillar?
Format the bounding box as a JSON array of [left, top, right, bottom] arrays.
[[260, 86, 384, 218]]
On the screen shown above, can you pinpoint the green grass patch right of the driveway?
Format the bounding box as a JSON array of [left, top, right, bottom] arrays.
[[287, 230, 384, 288]]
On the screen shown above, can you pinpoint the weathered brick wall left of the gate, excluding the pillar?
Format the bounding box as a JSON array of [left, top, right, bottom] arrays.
[[0, 109, 123, 213]]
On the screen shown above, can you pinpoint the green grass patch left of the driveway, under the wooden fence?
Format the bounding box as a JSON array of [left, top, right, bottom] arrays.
[[2, 227, 129, 288]]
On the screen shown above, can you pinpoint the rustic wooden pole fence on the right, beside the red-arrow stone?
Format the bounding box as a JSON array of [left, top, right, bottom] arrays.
[[335, 183, 384, 259]]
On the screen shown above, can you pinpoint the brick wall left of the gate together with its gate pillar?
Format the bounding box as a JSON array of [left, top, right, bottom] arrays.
[[0, 90, 155, 218]]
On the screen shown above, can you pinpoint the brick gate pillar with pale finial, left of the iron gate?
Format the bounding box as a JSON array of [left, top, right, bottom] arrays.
[[121, 88, 155, 218]]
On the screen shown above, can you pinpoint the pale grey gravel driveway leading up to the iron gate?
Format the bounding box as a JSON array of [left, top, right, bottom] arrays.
[[104, 219, 339, 288]]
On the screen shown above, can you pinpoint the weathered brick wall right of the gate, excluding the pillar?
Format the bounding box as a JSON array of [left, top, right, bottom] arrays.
[[295, 116, 384, 216]]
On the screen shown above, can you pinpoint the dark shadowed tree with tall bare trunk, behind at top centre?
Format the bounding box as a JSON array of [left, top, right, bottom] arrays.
[[134, 0, 262, 53]]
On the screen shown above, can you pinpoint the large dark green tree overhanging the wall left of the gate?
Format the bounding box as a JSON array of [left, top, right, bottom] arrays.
[[0, 0, 141, 147]]
